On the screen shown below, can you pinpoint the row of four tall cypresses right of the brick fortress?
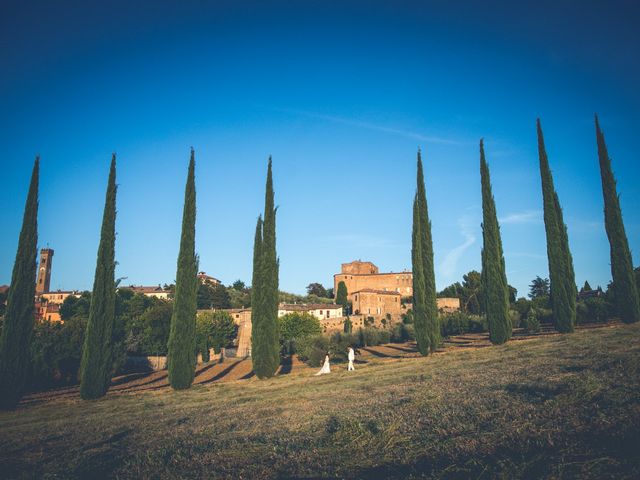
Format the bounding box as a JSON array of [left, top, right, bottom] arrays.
[[411, 115, 640, 355]]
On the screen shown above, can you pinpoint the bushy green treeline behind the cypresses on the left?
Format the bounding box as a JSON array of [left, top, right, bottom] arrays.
[[27, 288, 237, 390]]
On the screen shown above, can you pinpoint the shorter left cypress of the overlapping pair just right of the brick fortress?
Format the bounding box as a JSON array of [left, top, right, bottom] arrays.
[[411, 192, 431, 355]]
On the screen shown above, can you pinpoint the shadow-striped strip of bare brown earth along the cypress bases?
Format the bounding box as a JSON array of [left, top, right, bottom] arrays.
[[21, 322, 619, 405]]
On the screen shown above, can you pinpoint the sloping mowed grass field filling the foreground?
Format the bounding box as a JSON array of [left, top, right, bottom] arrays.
[[0, 325, 640, 479]]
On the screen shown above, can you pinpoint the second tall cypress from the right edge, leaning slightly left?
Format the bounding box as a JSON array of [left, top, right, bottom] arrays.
[[536, 119, 576, 333]]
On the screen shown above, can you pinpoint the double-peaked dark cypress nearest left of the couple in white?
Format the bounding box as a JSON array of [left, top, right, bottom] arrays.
[[251, 157, 280, 379]]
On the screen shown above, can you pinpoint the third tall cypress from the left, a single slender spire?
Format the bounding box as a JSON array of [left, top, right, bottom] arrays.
[[168, 148, 198, 390]]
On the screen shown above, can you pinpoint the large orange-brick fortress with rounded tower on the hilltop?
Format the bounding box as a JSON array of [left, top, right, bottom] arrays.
[[333, 260, 413, 297]]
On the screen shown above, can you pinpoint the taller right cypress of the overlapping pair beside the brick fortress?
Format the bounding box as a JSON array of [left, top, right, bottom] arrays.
[[416, 150, 440, 352]]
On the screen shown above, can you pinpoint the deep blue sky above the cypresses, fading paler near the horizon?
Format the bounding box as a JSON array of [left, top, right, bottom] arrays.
[[0, 1, 640, 295]]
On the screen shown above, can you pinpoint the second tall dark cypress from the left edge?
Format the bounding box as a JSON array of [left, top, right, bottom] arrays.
[[80, 154, 117, 400]]
